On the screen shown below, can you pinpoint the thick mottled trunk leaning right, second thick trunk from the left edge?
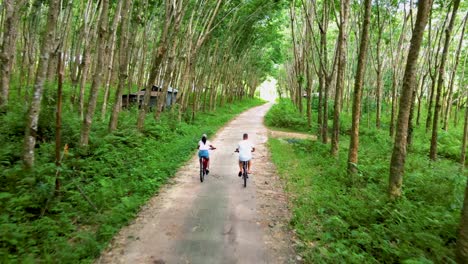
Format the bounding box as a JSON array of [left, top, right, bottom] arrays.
[[23, 0, 60, 169]]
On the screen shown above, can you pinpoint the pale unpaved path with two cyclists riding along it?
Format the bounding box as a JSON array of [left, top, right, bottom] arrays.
[[97, 104, 296, 264]]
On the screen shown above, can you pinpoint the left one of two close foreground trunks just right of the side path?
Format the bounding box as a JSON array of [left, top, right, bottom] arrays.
[[330, 0, 350, 156]]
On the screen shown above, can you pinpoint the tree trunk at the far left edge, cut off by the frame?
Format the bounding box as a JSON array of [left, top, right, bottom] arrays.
[[0, 0, 25, 112]]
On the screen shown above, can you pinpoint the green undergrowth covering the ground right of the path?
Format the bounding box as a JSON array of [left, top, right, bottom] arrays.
[[267, 99, 466, 263]]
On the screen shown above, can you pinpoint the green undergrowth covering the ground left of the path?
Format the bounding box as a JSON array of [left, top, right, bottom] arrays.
[[0, 99, 261, 263]]
